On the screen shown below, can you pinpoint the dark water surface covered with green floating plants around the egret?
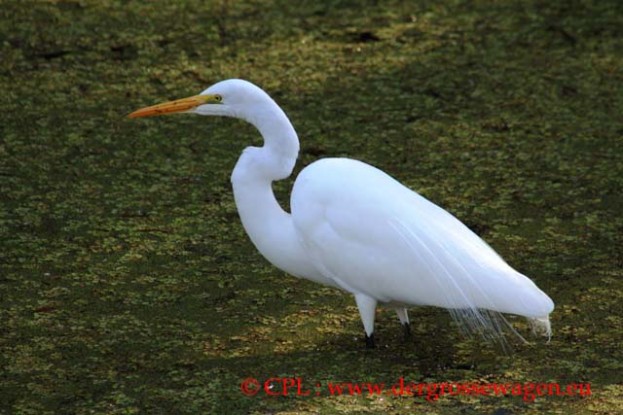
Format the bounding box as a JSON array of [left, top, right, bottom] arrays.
[[0, 0, 623, 415]]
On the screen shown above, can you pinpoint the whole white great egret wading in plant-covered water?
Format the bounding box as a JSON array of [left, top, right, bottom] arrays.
[[129, 79, 554, 347]]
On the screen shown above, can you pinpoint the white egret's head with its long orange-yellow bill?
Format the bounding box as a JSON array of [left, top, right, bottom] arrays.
[[128, 79, 276, 121]]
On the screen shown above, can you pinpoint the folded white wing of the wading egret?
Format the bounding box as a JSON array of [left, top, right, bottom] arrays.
[[291, 159, 553, 317]]
